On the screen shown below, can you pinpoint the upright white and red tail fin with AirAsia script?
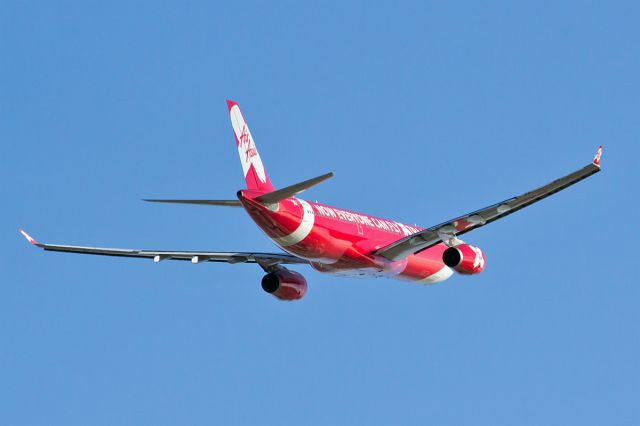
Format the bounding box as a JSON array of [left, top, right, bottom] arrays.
[[227, 100, 274, 192]]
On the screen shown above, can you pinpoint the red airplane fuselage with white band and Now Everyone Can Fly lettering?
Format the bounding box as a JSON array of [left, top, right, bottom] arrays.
[[238, 190, 453, 284]]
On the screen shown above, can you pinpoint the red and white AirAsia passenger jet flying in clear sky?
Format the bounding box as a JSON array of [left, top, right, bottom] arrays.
[[20, 100, 602, 301]]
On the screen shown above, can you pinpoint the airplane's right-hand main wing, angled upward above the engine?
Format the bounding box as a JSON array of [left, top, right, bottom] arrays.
[[375, 146, 602, 260]]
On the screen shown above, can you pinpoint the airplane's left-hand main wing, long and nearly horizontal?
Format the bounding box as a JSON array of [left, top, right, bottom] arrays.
[[20, 230, 309, 268]]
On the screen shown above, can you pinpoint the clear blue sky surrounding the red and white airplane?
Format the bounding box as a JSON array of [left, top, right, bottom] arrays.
[[0, 1, 640, 425]]
